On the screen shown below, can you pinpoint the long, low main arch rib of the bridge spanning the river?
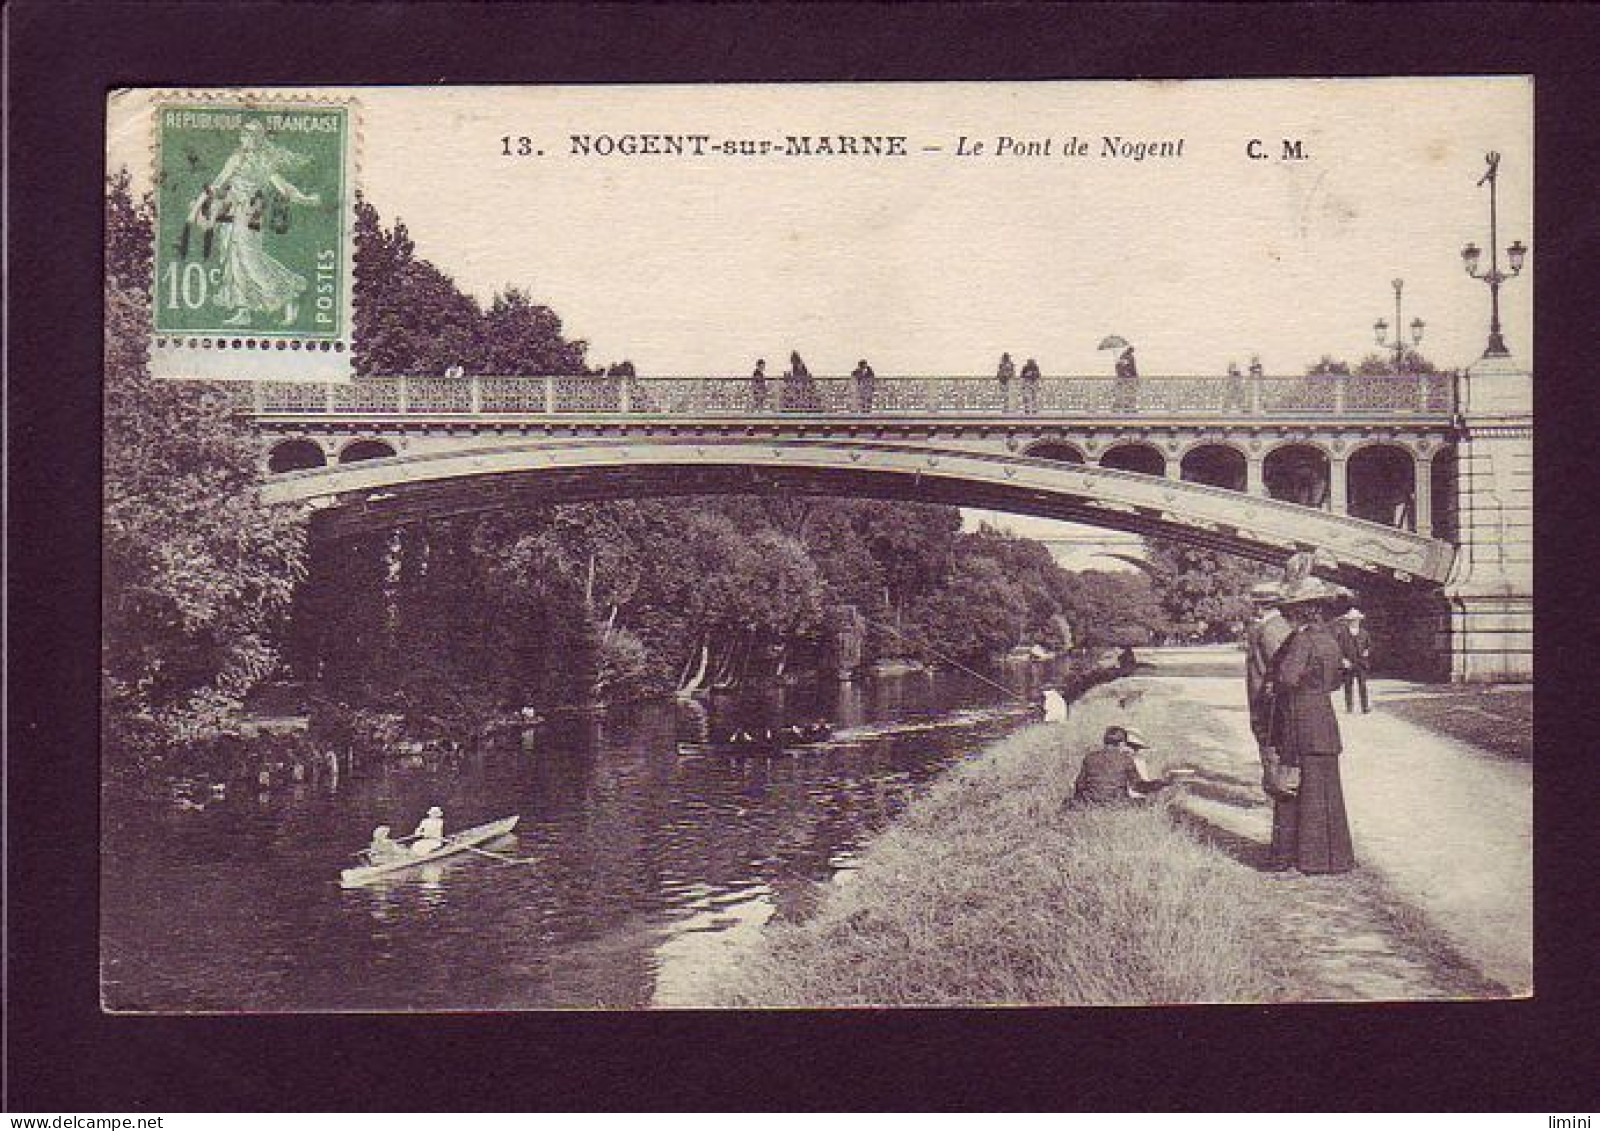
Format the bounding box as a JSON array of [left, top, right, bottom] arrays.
[[264, 437, 1454, 585]]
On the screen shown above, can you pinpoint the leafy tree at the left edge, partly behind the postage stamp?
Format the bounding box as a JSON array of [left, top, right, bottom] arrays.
[[101, 173, 306, 757]]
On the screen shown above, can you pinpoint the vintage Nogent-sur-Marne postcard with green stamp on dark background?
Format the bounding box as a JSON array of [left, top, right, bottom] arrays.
[[101, 77, 1538, 1013]]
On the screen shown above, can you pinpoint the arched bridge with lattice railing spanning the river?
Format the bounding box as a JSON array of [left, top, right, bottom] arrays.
[[238, 374, 1456, 585]]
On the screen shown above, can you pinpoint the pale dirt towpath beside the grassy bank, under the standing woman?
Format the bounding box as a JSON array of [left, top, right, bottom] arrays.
[[1114, 649, 1533, 1000]]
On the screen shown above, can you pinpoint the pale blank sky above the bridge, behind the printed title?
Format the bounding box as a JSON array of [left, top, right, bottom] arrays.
[[109, 78, 1539, 556]]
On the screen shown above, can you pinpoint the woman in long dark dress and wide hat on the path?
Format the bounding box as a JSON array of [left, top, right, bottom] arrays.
[[1270, 577, 1355, 873]]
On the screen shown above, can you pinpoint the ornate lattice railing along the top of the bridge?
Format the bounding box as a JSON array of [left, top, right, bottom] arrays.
[[235, 373, 1454, 421]]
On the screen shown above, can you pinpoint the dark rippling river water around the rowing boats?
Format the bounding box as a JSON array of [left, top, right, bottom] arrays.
[[101, 669, 1043, 1011]]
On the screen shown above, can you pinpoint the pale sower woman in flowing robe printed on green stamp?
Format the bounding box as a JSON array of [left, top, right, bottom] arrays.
[[190, 122, 322, 326]]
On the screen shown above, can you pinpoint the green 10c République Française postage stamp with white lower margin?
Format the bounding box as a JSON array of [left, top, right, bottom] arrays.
[[150, 93, 357, 381]]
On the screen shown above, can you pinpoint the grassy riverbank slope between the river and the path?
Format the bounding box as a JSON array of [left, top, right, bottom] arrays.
[[720, 689, 1280, 1006]]
